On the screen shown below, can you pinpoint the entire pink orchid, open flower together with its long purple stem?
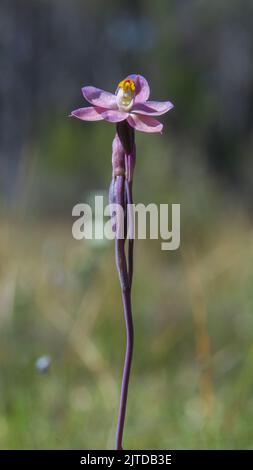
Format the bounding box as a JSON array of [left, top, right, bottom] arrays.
[[71, 75, 173, 450]]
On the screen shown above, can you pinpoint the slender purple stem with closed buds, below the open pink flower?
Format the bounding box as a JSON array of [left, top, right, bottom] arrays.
[[113, 126, 135, 450]]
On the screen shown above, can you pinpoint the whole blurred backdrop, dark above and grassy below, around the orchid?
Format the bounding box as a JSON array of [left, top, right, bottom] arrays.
[[0, 0, 253, 449]]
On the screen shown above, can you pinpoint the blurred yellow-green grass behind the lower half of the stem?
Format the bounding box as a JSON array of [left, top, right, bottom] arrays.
[[0, 208, 253, 449]]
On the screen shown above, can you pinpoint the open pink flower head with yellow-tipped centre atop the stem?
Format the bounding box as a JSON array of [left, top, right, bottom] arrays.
[[71, 75, 173, 133]]
